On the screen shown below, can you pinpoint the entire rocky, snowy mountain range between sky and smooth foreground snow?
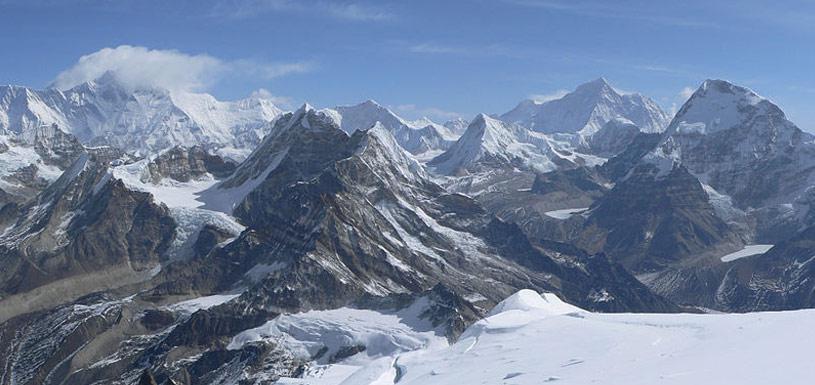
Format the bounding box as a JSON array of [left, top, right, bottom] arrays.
[[0, 73, 815, 385]]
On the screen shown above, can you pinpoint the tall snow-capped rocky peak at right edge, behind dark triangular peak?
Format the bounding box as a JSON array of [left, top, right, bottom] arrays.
[[657, 80, 815, 237]]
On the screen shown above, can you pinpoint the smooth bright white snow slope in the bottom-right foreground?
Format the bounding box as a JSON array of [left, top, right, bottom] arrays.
[[281, 290, 815, 385]]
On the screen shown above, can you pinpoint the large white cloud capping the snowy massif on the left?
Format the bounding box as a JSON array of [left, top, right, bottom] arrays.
[[53, 45, 313, 91]]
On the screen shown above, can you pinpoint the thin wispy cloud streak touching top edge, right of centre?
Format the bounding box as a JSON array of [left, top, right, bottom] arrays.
[[504, 0, 721, 28]]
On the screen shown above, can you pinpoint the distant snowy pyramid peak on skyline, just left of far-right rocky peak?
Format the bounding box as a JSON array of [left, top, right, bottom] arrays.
[[501, 78, 670, 136]]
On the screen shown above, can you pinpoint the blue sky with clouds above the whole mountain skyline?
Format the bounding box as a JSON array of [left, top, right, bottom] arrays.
[[0, 0, 815, 131]]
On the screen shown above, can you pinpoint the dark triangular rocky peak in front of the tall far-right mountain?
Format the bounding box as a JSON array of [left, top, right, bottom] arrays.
[[579, 163, 742, 272]]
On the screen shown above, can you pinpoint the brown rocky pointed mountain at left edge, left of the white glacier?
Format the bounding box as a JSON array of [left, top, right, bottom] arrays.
[[0, 155, 174, 319]]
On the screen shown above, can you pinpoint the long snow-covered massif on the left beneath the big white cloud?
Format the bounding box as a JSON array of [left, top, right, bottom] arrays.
[[0, 72, 282, 159]]
